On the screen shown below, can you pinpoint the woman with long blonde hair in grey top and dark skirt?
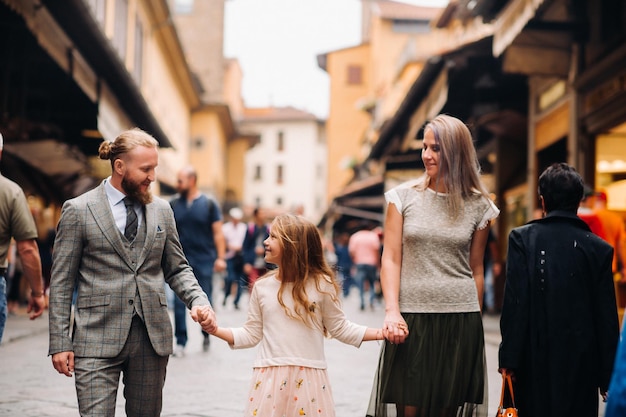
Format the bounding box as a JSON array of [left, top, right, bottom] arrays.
[[368, 115, 499, 417]]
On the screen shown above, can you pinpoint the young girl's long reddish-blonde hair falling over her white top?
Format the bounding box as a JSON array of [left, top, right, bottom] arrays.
[[270, 214, 340, 334]]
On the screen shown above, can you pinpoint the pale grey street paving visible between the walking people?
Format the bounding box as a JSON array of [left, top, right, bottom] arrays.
[[0, 290, 602, 417]]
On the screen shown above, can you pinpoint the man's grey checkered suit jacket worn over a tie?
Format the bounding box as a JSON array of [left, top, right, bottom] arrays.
[[49, 183, 209, 358]]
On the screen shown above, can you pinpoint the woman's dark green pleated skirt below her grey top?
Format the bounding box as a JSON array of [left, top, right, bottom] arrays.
[[367, 312, 488, 417]]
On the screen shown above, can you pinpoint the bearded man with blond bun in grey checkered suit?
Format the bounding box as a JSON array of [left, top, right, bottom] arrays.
[[49, 129, 216, 416]]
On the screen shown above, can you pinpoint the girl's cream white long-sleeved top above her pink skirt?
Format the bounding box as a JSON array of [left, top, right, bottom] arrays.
[[231, 275, 366, 369]]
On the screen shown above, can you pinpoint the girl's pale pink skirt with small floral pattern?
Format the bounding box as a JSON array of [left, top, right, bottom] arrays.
[[244, 366, 335, 417]]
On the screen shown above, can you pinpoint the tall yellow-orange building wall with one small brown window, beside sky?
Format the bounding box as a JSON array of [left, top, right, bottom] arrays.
[[326, 44, 371, 202]]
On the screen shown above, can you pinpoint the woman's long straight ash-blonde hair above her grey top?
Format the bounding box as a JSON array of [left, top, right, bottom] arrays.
[[421, 114, 489, 218]]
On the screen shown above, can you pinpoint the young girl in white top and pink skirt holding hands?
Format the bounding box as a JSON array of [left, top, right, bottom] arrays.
[[195, 214, 390, 417]]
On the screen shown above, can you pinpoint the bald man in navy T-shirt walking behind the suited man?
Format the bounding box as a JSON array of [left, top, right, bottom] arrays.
[[170, 166, 226, 357]]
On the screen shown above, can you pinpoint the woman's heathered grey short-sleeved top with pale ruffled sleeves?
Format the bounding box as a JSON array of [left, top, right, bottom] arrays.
[[385, 185, 500, 313]]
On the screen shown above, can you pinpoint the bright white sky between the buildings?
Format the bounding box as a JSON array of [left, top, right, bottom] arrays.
[[224, 0, 448, 118]]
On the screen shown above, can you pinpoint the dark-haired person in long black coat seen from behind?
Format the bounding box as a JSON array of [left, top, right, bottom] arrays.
[[499, 163, 619, 417]]
